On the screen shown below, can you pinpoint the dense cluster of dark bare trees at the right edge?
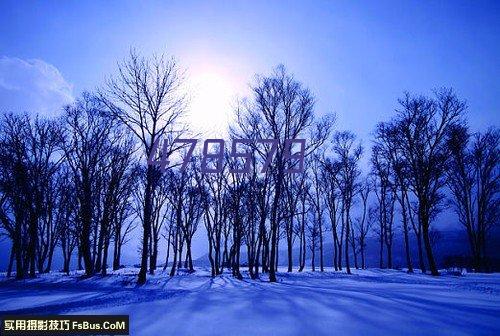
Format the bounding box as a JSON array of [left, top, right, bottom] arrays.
[[371, 89, 499, 275]]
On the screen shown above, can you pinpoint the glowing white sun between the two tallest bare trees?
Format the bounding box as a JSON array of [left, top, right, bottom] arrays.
[[188, 70, 236, 137]]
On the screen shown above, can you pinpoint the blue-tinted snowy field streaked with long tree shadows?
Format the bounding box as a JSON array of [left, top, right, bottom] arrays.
[[0, 268, 500, 335]]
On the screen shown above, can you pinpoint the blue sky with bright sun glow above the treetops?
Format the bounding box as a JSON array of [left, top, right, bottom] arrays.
[[0, 1, 500, 262]]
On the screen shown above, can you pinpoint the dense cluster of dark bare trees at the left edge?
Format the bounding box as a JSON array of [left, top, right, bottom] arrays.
[[0, 94, 139, 278]]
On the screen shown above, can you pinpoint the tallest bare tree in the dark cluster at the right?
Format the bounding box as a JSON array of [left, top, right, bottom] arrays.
[[394, 89, 466, 275]]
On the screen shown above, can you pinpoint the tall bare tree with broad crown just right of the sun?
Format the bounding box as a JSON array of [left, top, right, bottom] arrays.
[[233, 66, 331, 282]]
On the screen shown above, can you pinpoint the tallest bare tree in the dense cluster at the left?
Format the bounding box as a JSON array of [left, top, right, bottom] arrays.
[[62, 94, 113, 276]]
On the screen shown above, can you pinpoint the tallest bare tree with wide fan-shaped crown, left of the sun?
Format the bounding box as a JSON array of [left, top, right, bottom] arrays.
[[100, 50, 186, 284]]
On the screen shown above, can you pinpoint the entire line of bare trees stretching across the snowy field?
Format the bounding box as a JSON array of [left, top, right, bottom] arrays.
[[0, 51, 500, 284]]
